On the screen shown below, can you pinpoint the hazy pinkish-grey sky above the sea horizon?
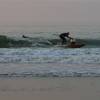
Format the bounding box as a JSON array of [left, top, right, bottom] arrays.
[[0, 0, 100, 25]]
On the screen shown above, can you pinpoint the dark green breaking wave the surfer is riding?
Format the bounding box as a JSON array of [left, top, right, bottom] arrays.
[[0, 36, 100, 48]]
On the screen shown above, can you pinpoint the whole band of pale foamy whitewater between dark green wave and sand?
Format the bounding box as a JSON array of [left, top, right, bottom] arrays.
[[0, 48, 100, 78]]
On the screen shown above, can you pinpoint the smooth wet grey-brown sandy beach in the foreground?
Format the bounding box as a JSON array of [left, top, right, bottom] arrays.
[[0, 77, 100, 100]]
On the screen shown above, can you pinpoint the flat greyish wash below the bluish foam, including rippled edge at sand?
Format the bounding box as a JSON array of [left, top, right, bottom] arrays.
[[0, 63, 100, 78]]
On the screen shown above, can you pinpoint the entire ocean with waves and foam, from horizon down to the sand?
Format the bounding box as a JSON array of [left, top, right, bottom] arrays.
[[0, 25, 100, 77]]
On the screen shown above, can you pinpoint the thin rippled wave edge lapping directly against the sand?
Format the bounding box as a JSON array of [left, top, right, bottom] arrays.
[[0, 72, 100, 78]]
